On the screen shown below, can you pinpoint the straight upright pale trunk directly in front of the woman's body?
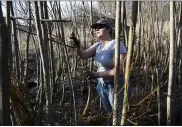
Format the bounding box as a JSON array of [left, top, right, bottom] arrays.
[[113, 1, 121, 126]]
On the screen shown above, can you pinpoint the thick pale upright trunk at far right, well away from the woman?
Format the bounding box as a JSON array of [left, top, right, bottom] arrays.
[[167, 1, 175, 126]]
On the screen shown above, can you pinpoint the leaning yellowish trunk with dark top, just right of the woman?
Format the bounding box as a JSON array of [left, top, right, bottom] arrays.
[[121, 1, 138, 126]]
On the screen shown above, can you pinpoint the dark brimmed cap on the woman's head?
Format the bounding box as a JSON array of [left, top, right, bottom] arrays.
[[91, 19, 113, 29]]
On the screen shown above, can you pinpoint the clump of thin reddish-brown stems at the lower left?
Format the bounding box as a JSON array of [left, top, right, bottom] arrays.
[[9, 76, 34, 126]]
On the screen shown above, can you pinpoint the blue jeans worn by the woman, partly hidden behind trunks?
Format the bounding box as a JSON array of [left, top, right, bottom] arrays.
[[96, 76, 124, 122]]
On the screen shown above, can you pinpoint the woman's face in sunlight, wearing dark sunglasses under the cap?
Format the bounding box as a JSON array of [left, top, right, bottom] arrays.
[[95, 25, 110, 39]]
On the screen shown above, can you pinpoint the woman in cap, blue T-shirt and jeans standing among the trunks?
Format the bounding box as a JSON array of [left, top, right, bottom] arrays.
[[70, 19, 127, 123]]
